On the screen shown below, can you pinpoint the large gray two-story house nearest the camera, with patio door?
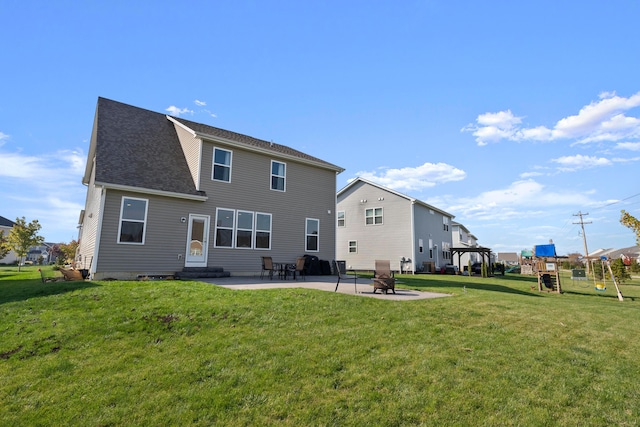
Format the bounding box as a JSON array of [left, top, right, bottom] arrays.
[[76, 98, 343, 279]]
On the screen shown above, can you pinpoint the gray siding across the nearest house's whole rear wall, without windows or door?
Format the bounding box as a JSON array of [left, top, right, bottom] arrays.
[[92, 142, 336, 278]]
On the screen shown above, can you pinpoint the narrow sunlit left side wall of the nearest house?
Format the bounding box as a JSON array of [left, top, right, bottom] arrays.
[[76, 168, 102, 269]]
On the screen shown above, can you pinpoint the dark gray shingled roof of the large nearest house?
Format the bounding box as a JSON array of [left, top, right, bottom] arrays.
[[89, 98, 343, 196]]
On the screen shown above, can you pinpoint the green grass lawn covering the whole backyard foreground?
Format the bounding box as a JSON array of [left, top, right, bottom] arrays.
[[0, 267, 640, 426]]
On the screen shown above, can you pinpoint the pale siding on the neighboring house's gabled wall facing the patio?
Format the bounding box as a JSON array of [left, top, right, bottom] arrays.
[[336, 183, 413, 270]]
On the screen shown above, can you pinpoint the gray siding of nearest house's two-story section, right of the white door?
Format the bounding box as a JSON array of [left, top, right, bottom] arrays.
[[200, 142, 336, 272]]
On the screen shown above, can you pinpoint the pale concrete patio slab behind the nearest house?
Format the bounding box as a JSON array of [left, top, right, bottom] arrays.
[[197, 276, 451, 301]]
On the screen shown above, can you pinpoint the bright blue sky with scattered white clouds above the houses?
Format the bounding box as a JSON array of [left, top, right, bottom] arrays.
[[0, 0, 640, 254]]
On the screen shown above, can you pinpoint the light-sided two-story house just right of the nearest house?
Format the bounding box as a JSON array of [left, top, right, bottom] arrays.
[[336, 178, 454, 272]]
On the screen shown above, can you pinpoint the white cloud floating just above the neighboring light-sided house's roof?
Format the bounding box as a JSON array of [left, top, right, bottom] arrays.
[[356, 163, 467, 191]]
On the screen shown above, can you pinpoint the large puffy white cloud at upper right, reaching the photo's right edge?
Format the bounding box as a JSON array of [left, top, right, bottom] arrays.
[[462, 92, 640, 146]]
